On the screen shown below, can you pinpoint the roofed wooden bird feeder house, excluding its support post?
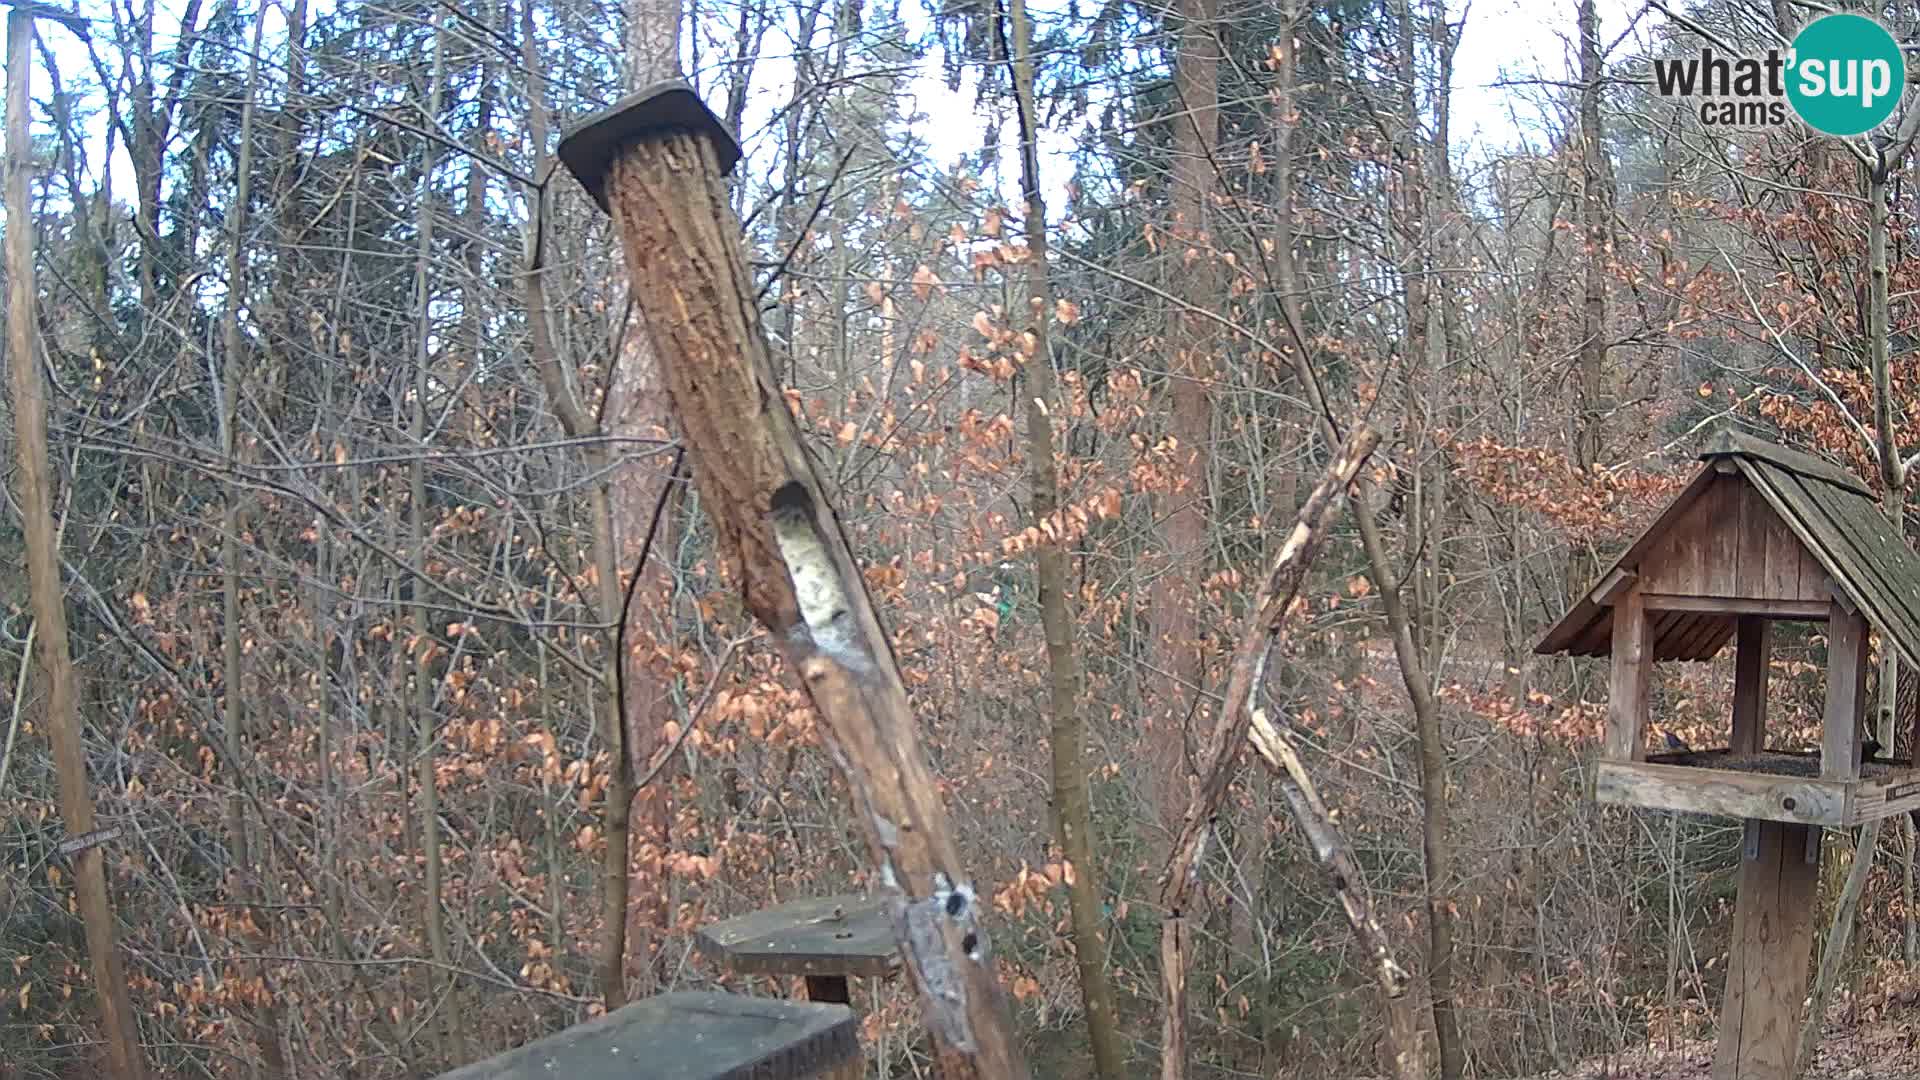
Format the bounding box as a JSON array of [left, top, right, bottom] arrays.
[[1536, 430, 1920, 826]]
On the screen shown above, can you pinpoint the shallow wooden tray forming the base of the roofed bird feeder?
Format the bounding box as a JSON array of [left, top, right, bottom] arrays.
[[1594, 749, 1920, 828]]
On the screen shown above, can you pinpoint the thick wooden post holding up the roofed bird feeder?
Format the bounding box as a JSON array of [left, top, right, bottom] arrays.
[[1713, 821, 1820, 1080]]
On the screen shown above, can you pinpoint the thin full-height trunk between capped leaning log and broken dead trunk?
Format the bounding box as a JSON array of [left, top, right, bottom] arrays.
[[1010, 0, 1127, 1080]]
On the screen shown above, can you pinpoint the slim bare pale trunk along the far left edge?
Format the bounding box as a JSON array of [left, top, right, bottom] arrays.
[[6, 8, 146, 1080]]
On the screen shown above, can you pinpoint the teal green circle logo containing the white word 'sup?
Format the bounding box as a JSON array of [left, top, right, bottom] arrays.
[[1788, 15, 1907, 136]]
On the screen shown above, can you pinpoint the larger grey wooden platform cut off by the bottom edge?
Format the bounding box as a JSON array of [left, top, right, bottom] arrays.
[[440, 992, 866, 1080]]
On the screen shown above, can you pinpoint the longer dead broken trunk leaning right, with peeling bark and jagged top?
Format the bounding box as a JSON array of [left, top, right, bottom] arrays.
[[1160, 425, 1380, 1080]]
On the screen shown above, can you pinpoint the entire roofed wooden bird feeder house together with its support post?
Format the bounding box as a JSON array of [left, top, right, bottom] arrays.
[[1536, 432, 1920, 1080]]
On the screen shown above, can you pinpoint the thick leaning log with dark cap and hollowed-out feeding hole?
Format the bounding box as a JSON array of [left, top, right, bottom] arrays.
[[559, 83, 1027, 1080]]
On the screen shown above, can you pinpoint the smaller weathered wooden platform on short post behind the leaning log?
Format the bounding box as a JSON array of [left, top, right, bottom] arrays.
[[693, 896, 900, 1003]]
